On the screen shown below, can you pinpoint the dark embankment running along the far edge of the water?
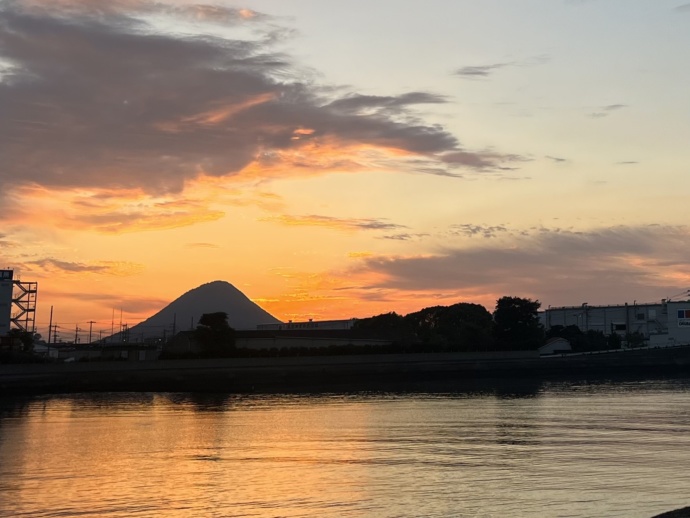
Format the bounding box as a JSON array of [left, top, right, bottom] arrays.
[[0, 347, 690, 394]]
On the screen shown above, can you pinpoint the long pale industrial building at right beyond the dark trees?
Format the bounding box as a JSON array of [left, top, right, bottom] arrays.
[[541, 300, 690, 347]]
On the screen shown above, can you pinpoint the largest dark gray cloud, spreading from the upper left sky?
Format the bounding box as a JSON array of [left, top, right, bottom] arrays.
[[0, 0, 512, 208]]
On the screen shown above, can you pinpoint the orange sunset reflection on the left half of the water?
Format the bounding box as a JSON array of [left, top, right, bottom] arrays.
[[0, 395, 376, 516]]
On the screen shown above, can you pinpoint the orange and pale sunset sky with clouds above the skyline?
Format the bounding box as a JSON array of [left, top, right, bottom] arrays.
[[0, 0, 690, 340]]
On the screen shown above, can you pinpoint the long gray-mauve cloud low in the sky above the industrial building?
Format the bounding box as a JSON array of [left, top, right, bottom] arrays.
[[354, 226, 690, 305]]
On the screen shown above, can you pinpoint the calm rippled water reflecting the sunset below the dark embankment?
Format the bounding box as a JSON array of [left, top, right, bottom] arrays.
[[0, 382, 690, 517]]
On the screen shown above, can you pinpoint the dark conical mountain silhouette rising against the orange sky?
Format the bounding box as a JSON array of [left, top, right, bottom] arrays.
[[121, 281, 280, 342]]
